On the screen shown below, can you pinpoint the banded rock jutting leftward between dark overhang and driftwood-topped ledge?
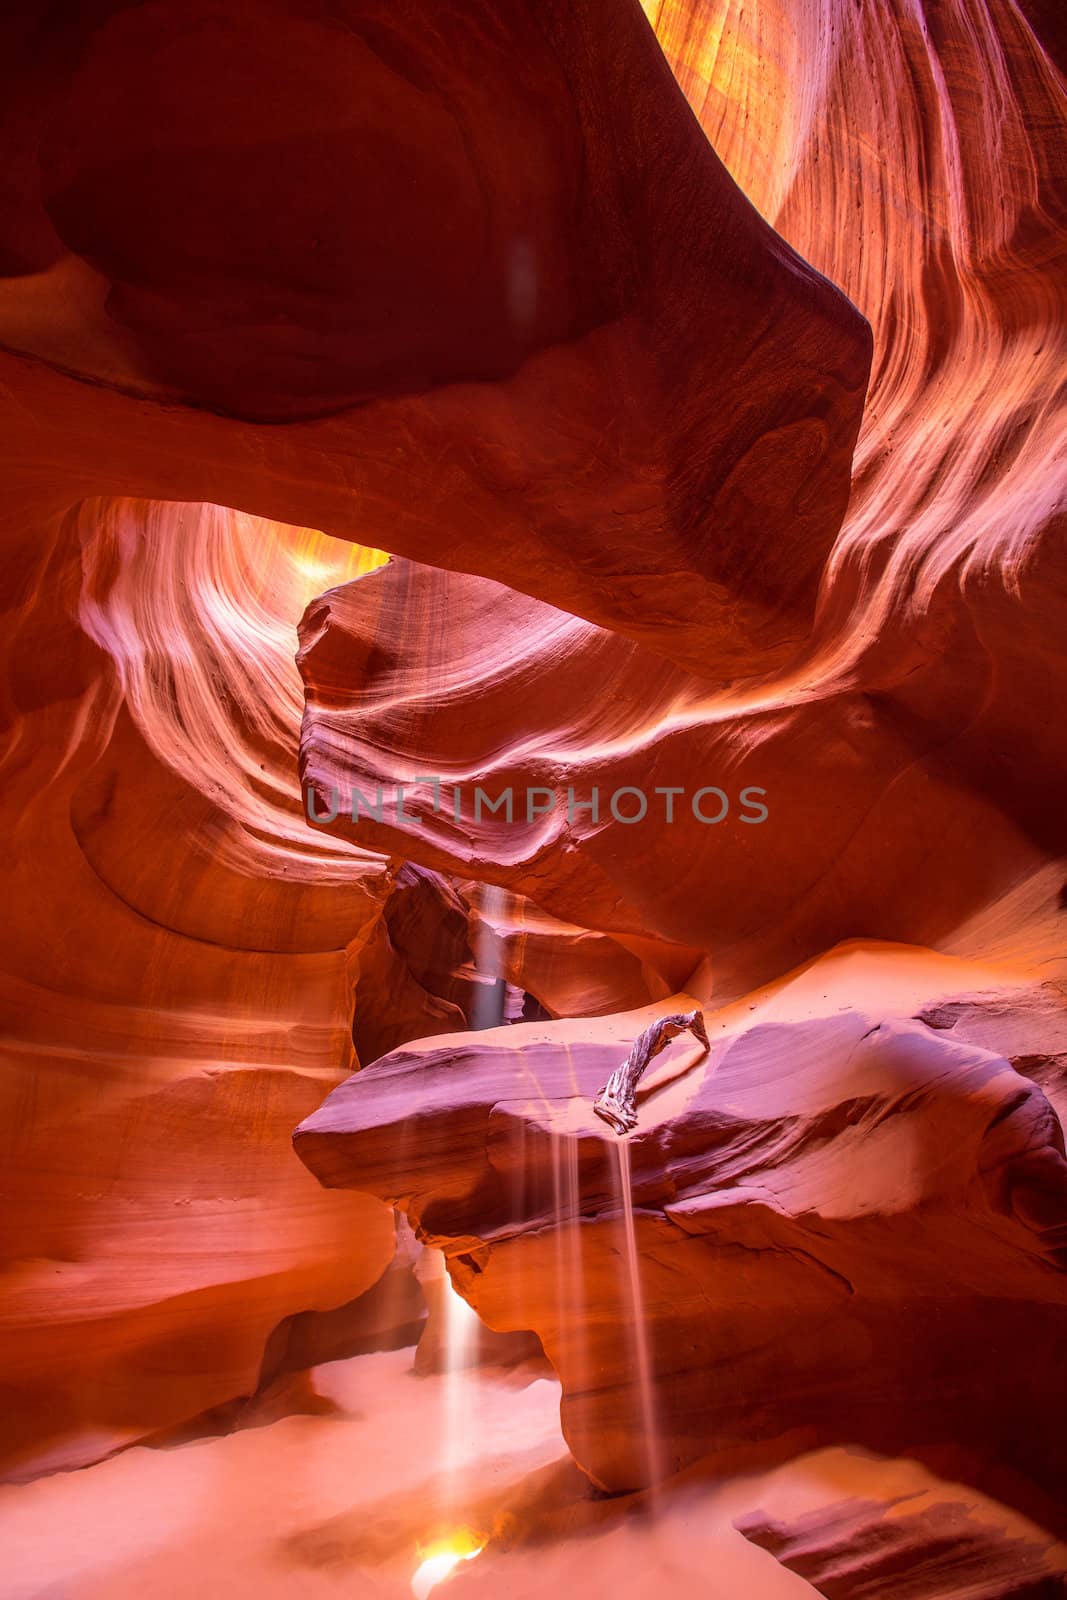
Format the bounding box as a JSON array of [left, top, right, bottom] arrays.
[[299, 560, 1067, 990]]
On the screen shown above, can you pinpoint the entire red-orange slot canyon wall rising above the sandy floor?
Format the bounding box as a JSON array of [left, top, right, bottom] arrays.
[[0, 0, 1067, 1592]]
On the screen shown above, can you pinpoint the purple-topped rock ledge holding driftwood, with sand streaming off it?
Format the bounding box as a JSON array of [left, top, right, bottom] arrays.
[[296, 973, 1067, 1490]]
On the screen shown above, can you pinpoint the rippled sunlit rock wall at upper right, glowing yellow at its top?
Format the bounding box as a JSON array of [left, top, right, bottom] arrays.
[[645, 0, 1067, 713]]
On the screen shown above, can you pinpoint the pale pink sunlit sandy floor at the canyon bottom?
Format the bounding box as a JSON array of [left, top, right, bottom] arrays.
[[0, 1350, 813, 1600]]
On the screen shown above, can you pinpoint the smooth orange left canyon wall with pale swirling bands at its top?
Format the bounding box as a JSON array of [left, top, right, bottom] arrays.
[[0, 502, 399, 1477]]
